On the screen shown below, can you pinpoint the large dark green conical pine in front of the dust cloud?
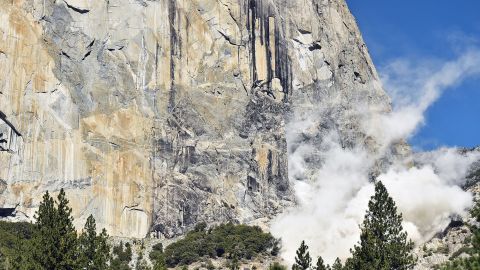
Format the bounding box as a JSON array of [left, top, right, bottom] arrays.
[[346, 182, 415, 270]]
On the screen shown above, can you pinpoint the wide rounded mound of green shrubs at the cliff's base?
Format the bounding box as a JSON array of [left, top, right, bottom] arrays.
[[159, 223, 278, 267]]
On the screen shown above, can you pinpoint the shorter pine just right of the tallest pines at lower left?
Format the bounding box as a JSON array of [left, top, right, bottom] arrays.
[[78, 215, 110, 270]]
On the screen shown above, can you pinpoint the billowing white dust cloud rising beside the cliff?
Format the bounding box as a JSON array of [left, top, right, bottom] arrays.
[[271, 50, 480, 263]]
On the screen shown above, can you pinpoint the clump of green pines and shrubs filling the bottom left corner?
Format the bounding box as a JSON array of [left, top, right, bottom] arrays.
[[0, 189, 110, 270]]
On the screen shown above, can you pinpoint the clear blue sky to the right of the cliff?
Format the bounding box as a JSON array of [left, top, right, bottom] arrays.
[[347, 0, 480, 150]]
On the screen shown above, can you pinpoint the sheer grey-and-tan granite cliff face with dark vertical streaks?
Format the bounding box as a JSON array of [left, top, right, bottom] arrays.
[[0, 0, 390, 237]]
